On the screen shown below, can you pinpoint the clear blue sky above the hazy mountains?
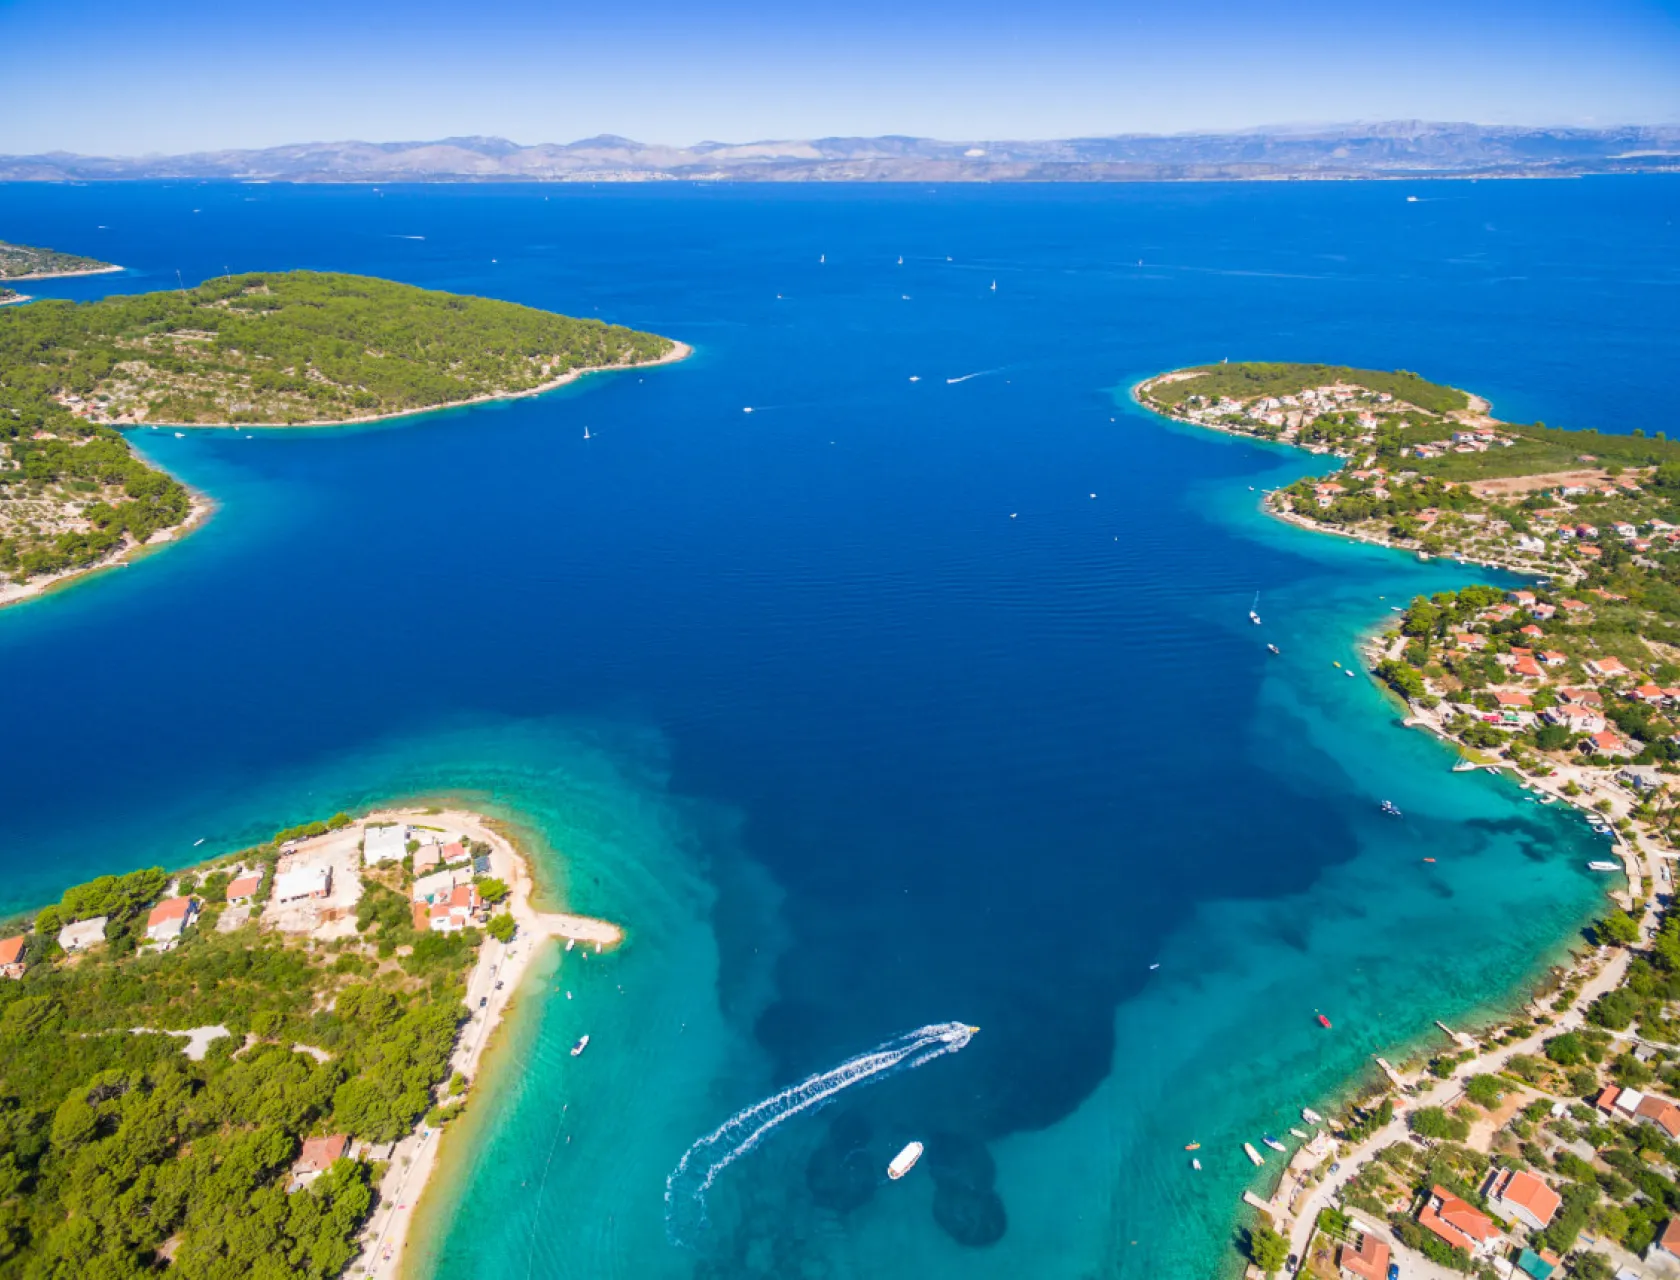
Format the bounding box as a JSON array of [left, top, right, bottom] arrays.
[[0, 0, 1680, 155]]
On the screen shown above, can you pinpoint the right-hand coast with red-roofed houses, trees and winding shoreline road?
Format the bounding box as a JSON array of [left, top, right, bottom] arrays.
[[1134, 363, 1680, 1280]]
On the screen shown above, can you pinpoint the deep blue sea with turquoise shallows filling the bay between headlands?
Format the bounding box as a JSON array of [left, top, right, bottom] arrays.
[[0, 178, 1680, 1280]]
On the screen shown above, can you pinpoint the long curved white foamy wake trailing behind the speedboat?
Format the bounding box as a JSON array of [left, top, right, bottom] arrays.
[[665, 1023, 979, 1245]]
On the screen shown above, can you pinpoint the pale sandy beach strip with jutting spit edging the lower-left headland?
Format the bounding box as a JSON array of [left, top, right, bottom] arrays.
[[349, 808, 623, 1277]]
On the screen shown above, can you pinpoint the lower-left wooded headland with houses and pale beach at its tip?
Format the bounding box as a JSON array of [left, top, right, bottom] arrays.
[[0, 806, 623, 1280]]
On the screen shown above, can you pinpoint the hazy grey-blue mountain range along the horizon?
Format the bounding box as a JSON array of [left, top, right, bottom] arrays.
[[0, 121, 1680, 183]]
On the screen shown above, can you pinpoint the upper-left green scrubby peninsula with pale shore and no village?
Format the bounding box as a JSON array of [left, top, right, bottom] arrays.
[[0, 265, 690, 606]]
